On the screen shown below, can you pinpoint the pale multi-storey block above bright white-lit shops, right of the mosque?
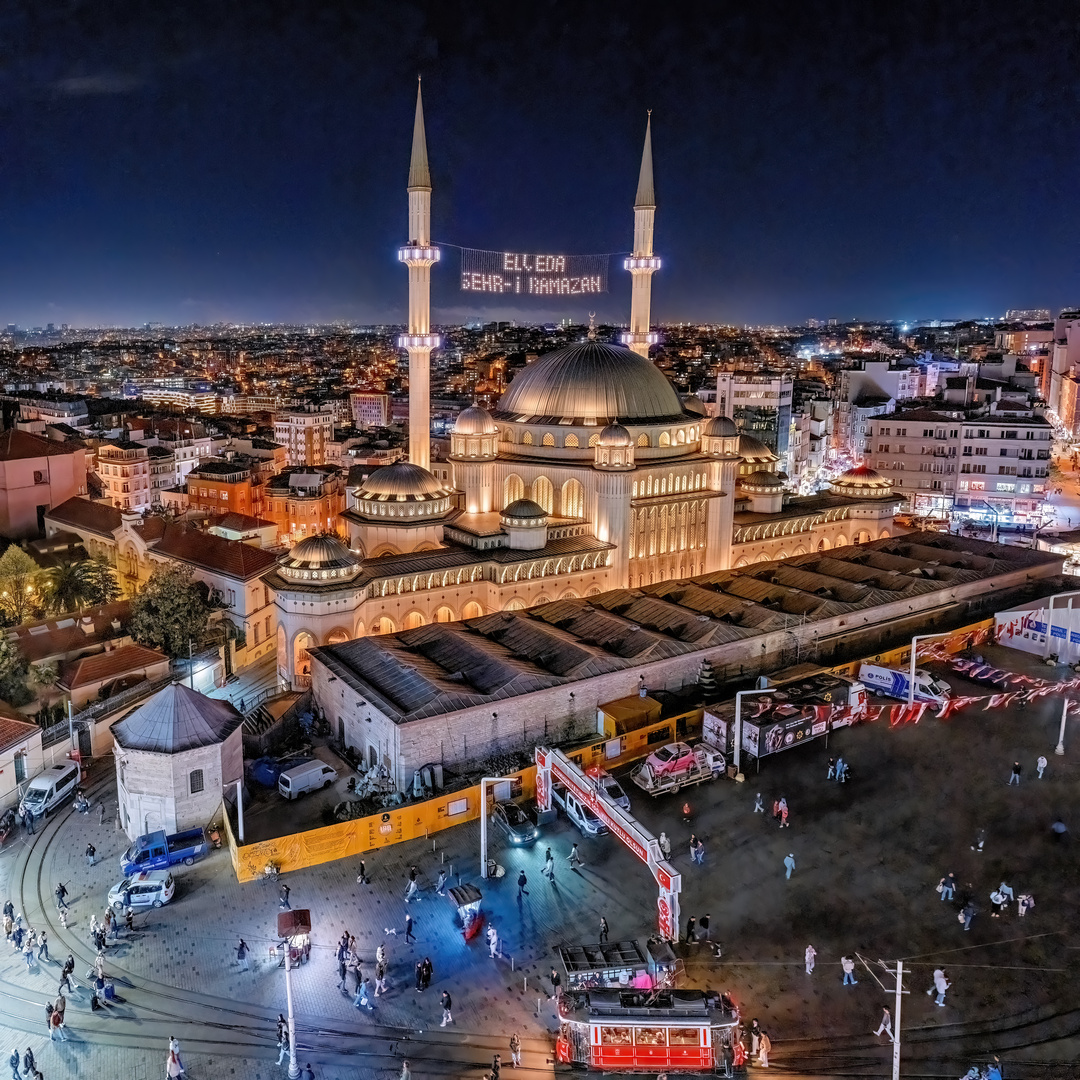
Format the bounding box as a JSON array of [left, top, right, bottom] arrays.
[[867, 403, 1053, 524]]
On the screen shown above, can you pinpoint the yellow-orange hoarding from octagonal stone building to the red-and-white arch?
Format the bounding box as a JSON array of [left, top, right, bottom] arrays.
[[225, 765, 537, 883]]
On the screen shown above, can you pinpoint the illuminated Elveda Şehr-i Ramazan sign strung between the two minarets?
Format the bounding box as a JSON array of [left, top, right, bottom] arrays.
[[461, 247, 608, 297]]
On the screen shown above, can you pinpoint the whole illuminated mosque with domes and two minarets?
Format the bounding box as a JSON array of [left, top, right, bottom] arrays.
[[265, 89, 900, 686]]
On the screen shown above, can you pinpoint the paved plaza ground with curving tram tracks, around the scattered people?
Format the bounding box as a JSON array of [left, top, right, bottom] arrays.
[[0, 650, 1080, 1080]]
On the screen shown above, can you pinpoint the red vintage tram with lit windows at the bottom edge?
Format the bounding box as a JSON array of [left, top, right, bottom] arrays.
[[555, 989, 746, 1077]]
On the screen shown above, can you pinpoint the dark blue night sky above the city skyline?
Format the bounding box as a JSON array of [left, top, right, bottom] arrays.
[[0, 0, 1080, 326]]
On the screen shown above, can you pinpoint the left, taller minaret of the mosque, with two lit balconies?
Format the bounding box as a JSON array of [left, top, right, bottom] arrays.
[[397, 79, 440, 469]]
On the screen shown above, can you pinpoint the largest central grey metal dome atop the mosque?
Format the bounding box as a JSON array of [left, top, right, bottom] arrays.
[[495, 341, 688, 427]]
